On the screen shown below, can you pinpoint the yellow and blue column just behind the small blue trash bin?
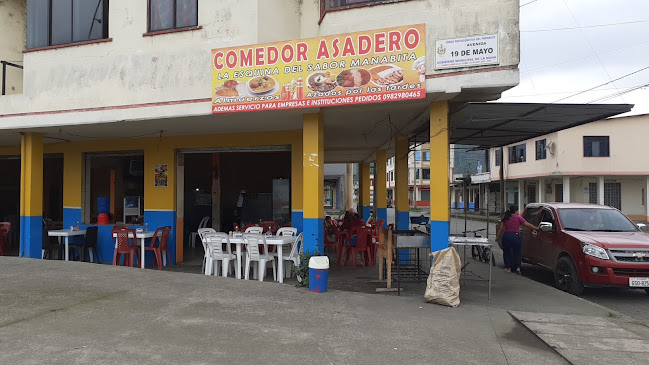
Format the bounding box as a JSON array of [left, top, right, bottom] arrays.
[[302, 114, 324, 252]]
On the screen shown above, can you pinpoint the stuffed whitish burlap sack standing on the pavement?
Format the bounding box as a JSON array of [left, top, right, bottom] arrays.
[[424, 247, 462, 307]]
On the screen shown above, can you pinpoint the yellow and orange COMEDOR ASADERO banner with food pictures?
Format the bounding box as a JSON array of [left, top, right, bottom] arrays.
[[212, 24, 426, 114]]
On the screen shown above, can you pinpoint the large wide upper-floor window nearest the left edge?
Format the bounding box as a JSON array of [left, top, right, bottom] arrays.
[[27, 0, 108, 49]]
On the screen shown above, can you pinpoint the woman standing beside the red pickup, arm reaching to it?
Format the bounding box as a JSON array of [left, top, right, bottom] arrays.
[[496, 205, 540, 275]]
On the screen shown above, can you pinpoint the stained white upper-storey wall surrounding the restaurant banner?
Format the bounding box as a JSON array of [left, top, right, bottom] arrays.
[[0, 0, 519, 118]]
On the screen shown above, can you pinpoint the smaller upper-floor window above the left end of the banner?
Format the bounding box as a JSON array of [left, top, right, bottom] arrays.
[[149, 0, 198, 32]]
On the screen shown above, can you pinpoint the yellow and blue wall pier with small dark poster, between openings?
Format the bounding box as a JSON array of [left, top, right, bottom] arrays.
[[144, 139, 176, 265]]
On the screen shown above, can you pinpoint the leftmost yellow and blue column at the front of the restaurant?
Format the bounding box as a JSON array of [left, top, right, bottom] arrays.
[[20, 133, 43, 259]]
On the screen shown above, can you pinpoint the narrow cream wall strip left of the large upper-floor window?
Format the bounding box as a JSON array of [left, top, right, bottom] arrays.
[[0, 0, 27, 95]]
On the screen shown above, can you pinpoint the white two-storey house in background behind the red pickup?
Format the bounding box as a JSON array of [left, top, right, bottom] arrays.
[[490, 114, 649, 221]]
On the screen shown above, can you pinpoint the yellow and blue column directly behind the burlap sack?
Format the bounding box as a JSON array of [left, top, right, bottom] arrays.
[[430, 101, 448, 251]]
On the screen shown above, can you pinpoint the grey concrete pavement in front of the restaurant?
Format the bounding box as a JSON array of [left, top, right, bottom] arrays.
[[0, 257, 649, 364]]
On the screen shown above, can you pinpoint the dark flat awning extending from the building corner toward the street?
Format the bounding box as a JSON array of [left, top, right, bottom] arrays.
[[414, 103, 633, 148]]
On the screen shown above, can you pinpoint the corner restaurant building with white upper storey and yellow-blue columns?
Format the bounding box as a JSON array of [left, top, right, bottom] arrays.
[[0, 0, 519, 261]]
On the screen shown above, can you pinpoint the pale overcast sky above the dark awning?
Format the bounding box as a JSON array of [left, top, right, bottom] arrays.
[[499, 0, 649, 114]]
